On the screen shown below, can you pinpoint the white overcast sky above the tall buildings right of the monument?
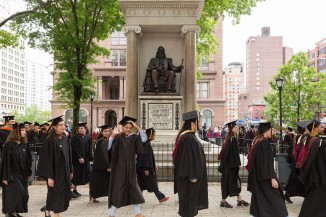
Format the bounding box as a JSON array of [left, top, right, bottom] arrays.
[[223, 0, 326, 67]]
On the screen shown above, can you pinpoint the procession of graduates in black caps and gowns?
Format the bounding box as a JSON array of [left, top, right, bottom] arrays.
[[0, 111, 326, 217]]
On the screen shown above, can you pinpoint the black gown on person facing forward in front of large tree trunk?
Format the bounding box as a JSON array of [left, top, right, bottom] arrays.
[[71, 135, 93, 185]]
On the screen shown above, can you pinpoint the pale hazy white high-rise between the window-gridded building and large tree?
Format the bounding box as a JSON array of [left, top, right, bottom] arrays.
[[26, 60, 52, 111]]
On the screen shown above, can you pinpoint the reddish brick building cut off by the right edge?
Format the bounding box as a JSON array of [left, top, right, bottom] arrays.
[[307, 38, 326, 73]]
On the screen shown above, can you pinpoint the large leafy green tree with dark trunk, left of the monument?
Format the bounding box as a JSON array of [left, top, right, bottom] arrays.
[[10, 0, 124, 131]]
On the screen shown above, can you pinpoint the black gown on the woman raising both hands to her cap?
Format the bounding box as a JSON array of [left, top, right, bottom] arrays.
[[108, 134, 145, 208]]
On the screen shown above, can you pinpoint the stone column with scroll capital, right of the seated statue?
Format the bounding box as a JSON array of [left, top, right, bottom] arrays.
[[181, 25, 200, 112]]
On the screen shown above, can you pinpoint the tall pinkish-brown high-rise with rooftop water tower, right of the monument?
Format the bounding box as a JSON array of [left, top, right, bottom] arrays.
[[240, 27, 293, 118]]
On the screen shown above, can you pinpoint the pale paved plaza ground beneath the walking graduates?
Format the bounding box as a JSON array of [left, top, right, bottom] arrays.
[[0, 182, 303, 217]]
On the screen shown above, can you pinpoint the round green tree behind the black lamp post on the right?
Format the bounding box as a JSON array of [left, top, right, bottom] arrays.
[[264, 52, 326, 126]]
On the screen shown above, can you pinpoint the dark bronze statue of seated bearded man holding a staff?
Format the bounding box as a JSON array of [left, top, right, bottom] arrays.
[[146, 46, 183, 92]]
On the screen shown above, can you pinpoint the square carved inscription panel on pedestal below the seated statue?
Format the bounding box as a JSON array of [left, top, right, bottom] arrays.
[[148, 103, 173, 130]]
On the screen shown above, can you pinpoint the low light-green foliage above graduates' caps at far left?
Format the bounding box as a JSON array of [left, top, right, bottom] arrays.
[[10, 105, 51, 123]]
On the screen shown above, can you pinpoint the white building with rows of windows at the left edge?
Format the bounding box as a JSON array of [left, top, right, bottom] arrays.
[[0, 39, 26, 116]]
